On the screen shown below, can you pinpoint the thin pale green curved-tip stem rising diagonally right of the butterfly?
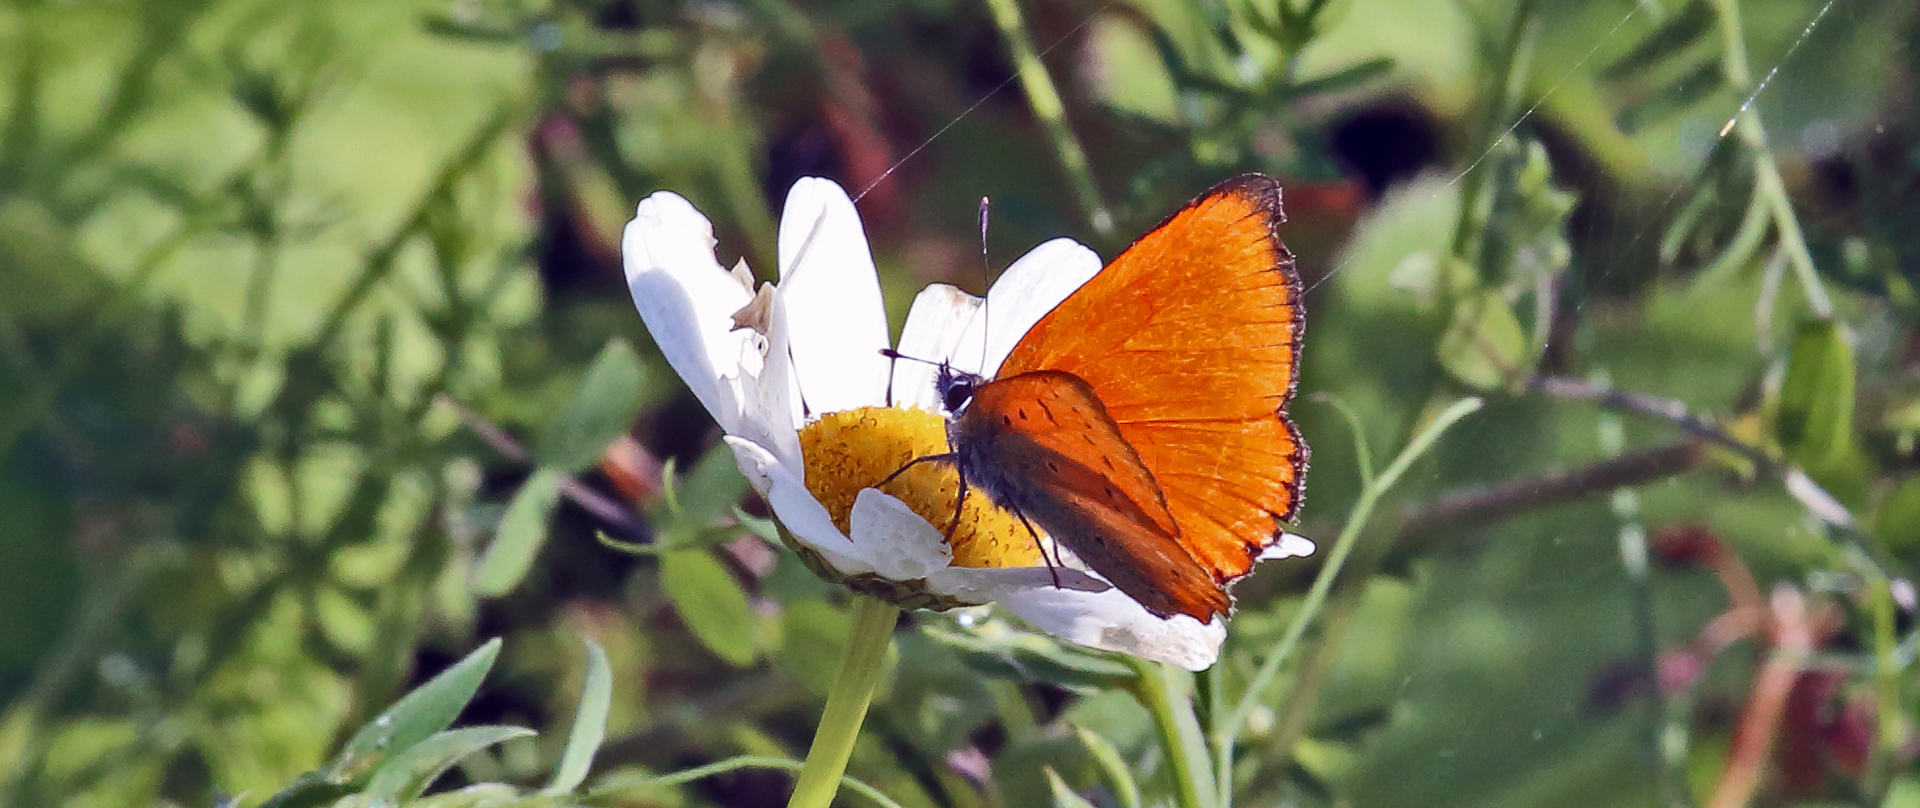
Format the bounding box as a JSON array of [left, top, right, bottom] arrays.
[[1213, 397, 1482, 804]]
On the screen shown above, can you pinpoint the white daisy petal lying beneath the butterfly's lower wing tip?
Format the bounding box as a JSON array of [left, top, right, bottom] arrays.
[[1000, 587, 1227, 670]]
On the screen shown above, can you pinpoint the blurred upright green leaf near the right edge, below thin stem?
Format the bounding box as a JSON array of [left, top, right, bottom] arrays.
[[1774, 321, 1855, 470]]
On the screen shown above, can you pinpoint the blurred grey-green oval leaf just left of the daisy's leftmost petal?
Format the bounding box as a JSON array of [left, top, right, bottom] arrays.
[[534, 338, 645, 472]]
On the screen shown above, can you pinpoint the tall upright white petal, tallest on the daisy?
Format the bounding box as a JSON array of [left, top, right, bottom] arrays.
[[780, 177, 889, 413]]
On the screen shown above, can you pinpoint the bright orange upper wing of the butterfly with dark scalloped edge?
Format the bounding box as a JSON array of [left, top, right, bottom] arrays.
[[989, 175, 1308, 587]]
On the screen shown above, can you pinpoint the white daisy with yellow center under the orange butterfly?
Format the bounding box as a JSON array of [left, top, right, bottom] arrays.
[[622, 178, 1313, 670]]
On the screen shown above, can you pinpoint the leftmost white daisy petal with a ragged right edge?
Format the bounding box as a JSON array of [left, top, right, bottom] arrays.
[[620, 190, 760, 432]]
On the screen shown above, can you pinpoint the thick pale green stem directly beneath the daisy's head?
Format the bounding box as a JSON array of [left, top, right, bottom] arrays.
[[787, 597, 900, 808]]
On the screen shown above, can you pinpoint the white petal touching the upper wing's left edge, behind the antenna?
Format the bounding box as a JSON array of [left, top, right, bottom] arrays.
[[952, 238, 1100, 378]]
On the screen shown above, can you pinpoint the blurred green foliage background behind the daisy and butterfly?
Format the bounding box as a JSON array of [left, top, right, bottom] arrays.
[[0, 0, 1920, 806]]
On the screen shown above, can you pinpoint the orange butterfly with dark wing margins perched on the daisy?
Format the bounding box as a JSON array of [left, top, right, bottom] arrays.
[[889, 175, 1308, 624]]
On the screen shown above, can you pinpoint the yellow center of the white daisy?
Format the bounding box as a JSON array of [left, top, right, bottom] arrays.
[[801, 407, 1044, 566]]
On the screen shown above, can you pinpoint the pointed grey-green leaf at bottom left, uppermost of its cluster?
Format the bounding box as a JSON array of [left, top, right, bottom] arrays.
[[326, 637, 499, 783]]
